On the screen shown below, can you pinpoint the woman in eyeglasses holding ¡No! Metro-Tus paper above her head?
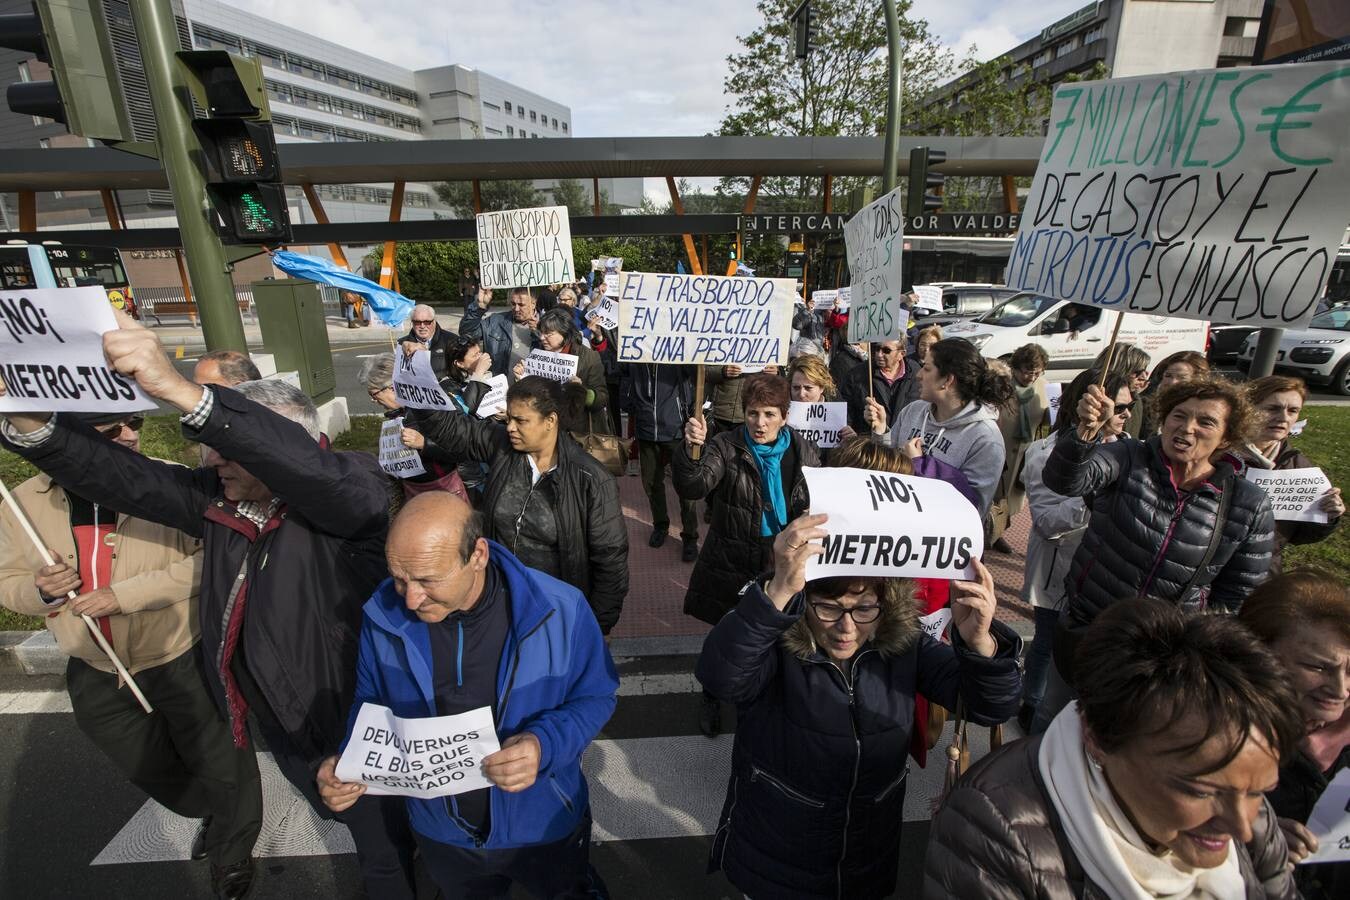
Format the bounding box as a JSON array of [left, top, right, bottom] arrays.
[[695, 515, 1021, 900]]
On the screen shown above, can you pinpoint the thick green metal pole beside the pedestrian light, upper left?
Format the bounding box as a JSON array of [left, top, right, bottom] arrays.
[[128, 0, 248, 352]]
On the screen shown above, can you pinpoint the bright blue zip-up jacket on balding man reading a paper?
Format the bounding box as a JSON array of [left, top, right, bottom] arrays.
[[344, 541, 618, 850]]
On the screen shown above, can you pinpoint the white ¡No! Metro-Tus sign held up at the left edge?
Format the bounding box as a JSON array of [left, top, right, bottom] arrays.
[[0, 287, 155, 413]]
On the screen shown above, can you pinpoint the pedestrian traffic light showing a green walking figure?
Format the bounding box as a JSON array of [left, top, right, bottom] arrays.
[[177, 50, 290, 244]]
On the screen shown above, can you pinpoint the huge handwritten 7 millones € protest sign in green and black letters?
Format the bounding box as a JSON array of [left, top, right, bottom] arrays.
[[1007, 61, 1350, 328]]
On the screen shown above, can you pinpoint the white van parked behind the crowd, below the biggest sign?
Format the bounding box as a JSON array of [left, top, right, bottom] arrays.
[[942, 293, 1210, 368]]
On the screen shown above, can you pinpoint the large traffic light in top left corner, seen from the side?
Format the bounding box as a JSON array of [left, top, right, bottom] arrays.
[[0, 0, 132, 142]]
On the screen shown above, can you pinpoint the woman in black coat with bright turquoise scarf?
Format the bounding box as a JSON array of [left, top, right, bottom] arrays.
[[675, 372, 821, 737]]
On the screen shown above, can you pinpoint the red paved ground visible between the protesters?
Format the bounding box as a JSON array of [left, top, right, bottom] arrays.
[[613, 464, 1031, 637]]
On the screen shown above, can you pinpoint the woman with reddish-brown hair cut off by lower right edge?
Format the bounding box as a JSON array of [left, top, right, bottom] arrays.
[[1238, 569, 1350, 900]]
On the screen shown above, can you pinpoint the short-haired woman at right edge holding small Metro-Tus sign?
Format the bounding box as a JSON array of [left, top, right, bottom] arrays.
[[1239, 375, 1346, 575]]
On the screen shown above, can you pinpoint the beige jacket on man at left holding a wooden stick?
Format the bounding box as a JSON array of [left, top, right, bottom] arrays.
[[0, 475, 201, 673]]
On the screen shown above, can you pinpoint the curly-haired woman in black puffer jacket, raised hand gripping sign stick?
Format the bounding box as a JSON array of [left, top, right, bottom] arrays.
[[1033, 378, 1274, 731]]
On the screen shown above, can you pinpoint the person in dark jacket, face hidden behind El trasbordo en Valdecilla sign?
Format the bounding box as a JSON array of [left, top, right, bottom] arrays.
[[620, 363, 698, 563]]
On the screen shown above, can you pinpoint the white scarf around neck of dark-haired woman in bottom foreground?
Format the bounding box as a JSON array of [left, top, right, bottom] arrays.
[[1038, 703, 1246, 900]]
